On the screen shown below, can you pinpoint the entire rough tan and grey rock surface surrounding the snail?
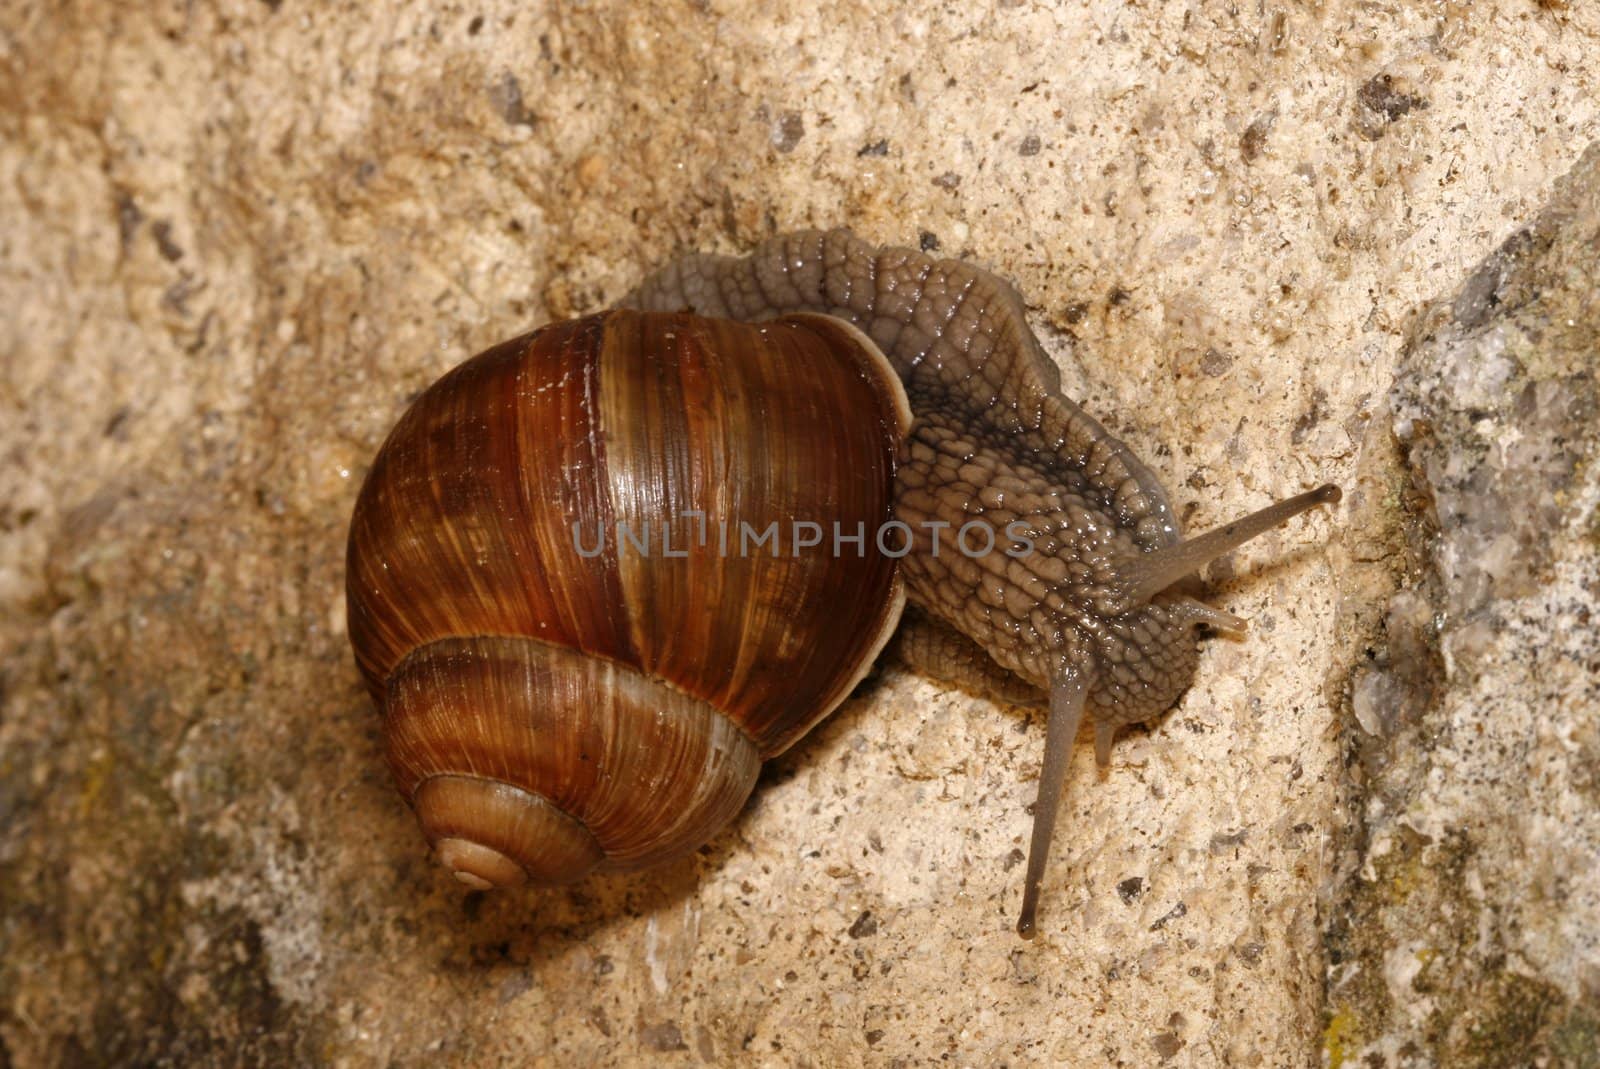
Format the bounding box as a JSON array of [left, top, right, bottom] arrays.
[[0, 0, 1600, 1066]]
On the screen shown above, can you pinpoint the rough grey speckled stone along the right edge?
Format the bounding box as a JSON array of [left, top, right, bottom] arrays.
[[1326, 146, 1600, 1066]]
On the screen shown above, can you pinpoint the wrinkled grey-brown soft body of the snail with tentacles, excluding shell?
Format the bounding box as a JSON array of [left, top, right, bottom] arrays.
[[624, 230, 1339, 936]]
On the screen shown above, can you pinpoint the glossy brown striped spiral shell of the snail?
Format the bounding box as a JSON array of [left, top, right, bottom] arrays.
[[347, 312, 910, 887]]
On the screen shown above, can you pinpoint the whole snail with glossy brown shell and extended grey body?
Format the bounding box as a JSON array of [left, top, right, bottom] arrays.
[[347, 230, 1339, 938]]
